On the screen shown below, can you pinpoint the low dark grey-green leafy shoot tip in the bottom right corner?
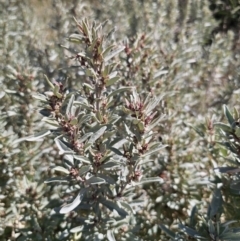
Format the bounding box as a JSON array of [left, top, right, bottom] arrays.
[[160, 188, 240, 241]]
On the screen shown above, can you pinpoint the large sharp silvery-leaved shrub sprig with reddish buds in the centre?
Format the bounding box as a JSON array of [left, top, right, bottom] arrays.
[[27, 19, 165, 240]]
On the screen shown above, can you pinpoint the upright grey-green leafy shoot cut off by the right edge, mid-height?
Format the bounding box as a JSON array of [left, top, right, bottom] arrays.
[[211, 105, 240, 226]]
